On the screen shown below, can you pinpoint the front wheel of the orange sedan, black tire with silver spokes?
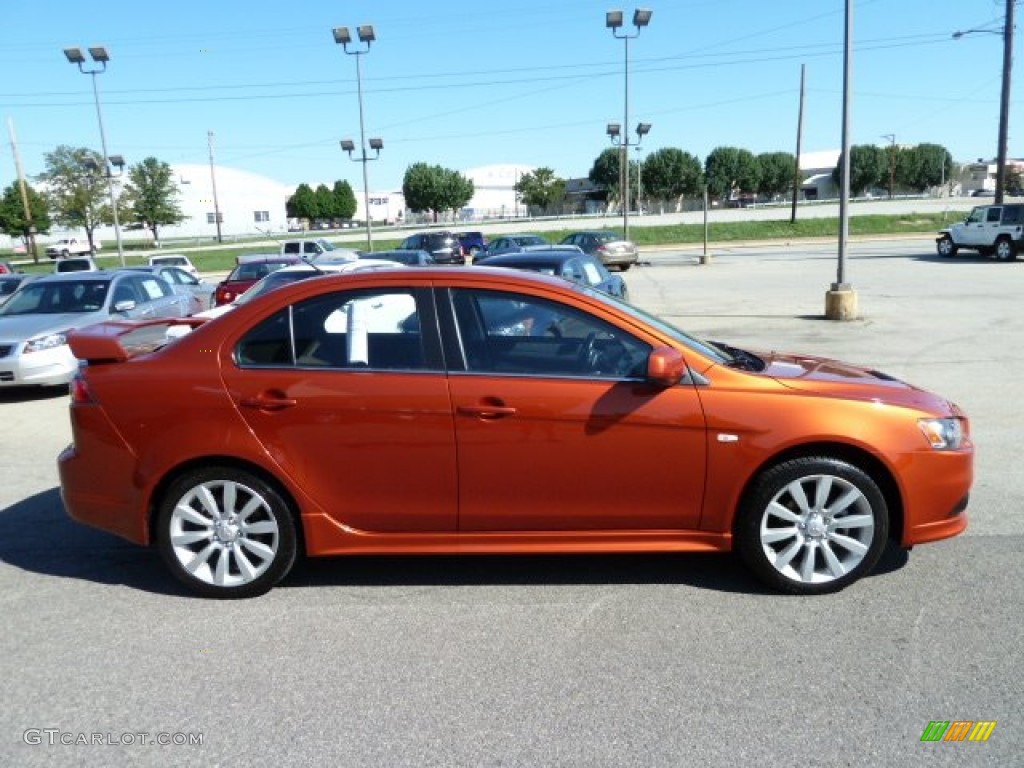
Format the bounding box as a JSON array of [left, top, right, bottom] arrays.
[[734, 456, 889, 595]]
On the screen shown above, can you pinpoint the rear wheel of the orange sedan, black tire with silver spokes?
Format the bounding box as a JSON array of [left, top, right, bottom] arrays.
[[156, 466, 296, 598]]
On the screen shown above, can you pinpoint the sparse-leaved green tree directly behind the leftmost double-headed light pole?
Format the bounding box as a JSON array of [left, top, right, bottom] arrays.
[[39, 144, 114, 250]]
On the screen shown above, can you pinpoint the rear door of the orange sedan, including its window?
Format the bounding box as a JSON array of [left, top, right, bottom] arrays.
[[223, 288, 457, 532]]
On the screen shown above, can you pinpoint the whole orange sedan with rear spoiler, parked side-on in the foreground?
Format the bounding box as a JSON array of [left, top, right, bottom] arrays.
[[58, 267, 973, 597]]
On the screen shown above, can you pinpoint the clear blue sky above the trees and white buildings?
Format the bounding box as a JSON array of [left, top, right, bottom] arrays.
[[0, 0, 1024, 190]]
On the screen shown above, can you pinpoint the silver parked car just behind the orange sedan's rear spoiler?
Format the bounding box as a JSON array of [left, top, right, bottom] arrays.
[[0, 269, 191, 387]]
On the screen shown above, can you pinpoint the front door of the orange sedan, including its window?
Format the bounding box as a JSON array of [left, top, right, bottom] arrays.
[[439, 289, 707, 531]]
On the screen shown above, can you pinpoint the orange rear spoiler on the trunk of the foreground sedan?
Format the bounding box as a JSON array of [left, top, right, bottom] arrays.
[[68, 317, 209, 365]]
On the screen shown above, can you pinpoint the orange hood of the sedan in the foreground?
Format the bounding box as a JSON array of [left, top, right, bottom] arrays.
[[756, 352, 953, 413]]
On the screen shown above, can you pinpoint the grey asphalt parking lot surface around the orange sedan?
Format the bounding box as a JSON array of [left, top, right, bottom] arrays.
[[0, 239, 1024, 766]]
